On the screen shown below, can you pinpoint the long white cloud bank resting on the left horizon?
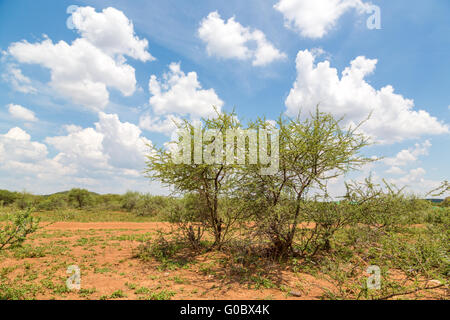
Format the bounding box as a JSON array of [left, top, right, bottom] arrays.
[[0, 121, 160, 194]]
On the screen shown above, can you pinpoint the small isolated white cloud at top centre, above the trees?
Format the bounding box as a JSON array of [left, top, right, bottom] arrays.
[[198, 11, 286, 66]]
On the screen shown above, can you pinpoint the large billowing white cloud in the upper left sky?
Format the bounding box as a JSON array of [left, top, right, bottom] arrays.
[[8, 7, 154, 110]]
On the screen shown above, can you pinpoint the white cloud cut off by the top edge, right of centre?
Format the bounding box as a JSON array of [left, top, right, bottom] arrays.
[[274, 0, 369, 38]]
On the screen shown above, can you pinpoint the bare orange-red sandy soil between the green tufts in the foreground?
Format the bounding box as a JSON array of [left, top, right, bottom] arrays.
[[0, 222, 446, 300]]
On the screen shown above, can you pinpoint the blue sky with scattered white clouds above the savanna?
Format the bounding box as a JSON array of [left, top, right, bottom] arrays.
[[0, 0, 450, 193]]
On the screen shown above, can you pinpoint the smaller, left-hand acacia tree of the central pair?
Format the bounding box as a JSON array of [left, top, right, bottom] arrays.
[[146, 112, 241, 248]]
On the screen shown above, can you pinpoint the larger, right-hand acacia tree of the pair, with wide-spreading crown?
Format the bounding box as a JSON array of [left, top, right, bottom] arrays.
[[240, 108, 374, 256]]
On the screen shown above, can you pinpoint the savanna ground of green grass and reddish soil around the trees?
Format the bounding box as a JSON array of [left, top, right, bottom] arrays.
[[0, 189, 450, 300]]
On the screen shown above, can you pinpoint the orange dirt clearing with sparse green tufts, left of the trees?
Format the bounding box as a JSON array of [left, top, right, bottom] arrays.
[[0, 222, 446, 300]]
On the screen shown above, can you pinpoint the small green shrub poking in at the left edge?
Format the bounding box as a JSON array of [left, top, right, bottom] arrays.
[[0, 209, 39, 250]]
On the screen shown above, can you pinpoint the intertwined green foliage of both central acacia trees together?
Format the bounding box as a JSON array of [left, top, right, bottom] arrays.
[[147, 110, 373, 255]]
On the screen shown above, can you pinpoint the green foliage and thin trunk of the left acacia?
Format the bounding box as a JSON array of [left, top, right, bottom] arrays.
[[146, 109, 246, 248]]
